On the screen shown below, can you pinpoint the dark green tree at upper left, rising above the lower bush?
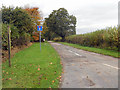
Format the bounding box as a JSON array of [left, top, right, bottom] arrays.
[[2, 6, 33, 35]]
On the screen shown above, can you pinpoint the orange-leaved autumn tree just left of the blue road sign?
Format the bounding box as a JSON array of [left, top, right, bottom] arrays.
[[25, 7, 43, 41]]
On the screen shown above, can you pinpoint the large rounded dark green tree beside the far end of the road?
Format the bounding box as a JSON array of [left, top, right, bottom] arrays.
[[45, 8, 76, 41]]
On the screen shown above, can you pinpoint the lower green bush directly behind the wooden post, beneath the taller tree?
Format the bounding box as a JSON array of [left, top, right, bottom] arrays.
[[2, 24, 31, 50]]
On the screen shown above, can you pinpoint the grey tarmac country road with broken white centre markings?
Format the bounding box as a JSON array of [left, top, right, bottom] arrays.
[[50, 42, 119, 88]]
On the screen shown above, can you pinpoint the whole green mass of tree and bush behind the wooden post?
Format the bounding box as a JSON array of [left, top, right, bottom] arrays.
[[2, 6, 33, 49]]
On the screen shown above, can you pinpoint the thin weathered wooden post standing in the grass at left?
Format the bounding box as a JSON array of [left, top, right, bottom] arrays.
[[8, 25, 11, 67]]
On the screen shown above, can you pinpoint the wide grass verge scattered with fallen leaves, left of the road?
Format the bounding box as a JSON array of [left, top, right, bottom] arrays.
[[2, 42, 62, 88]]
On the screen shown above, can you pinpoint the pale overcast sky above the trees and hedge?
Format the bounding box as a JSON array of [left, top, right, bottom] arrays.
[[0, 0, 119, 34]]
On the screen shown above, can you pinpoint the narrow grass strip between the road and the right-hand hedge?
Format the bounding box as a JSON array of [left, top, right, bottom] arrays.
[[59, 42, 120, 58]]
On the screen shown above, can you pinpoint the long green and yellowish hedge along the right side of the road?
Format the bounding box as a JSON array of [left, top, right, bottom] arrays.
[[66, 27, 120, 50]]
